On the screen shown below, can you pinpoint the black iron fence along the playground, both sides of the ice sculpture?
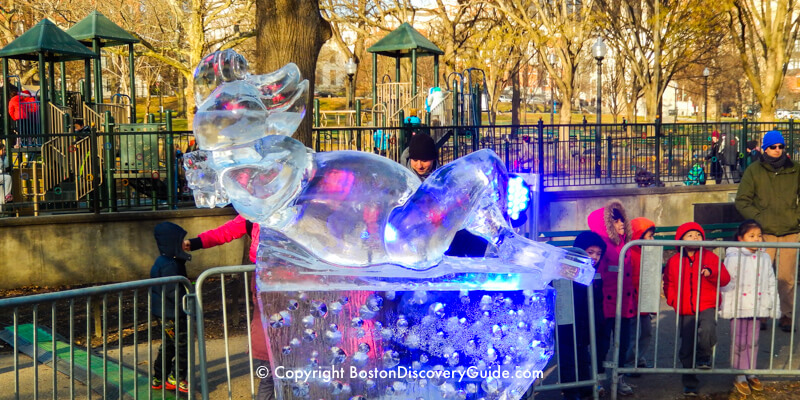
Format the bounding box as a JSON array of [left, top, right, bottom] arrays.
[[0, 119, 800, 216]]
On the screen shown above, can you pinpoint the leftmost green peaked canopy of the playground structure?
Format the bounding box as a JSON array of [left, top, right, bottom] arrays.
[[0, 18, 97, 62]]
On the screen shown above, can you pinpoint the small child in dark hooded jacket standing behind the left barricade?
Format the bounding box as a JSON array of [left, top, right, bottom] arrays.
[[150, 222, 192, 393]]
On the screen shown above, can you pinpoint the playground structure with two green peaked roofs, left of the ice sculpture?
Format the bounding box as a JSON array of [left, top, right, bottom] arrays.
[[0, 11, 189, 215]]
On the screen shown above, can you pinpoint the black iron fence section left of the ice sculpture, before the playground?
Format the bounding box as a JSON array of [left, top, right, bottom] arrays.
[[0, 113, 195, 216]]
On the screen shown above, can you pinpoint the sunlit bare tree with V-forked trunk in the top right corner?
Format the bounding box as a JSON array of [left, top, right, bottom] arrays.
[[728, 0, 800, 121]]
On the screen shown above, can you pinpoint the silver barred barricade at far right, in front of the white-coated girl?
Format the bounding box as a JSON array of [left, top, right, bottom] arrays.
[[606, 240, 800, 399]]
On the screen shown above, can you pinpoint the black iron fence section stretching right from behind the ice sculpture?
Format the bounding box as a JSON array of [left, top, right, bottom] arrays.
[[313, 120, 800, 187]]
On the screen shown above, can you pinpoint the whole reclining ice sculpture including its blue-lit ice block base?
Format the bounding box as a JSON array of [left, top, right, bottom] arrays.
[[184, 50, 594, 400]]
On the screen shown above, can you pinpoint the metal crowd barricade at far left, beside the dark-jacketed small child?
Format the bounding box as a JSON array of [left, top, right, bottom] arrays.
[[0, 276, 197, 399]]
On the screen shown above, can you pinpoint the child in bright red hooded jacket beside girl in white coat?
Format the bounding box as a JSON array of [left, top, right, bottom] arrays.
[[664, 222, 731, 395]]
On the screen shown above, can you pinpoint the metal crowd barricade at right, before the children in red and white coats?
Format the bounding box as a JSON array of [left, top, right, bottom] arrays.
[[604, 240, 800, 398]]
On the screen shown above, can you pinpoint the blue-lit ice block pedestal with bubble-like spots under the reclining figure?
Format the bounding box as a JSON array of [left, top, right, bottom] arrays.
[[257, 253, 555, 400]]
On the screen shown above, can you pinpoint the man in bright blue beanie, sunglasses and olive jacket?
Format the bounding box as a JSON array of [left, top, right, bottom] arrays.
[[736, 131, 800, 332]]
